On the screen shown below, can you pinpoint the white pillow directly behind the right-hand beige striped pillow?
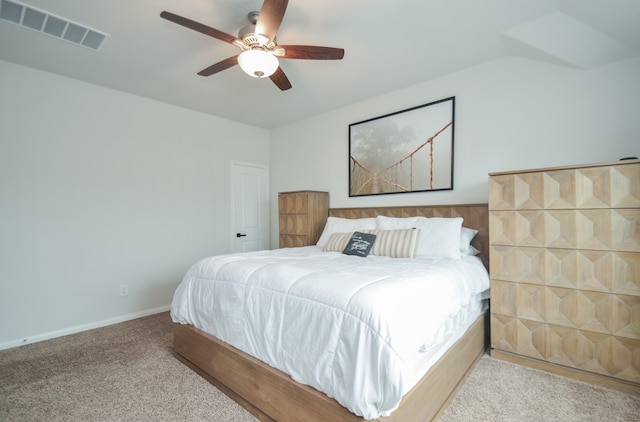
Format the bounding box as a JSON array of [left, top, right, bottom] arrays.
[[376, 215, 462, 259]]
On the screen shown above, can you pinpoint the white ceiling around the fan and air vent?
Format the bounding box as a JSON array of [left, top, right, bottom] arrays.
[[0, 0, 640, 128]]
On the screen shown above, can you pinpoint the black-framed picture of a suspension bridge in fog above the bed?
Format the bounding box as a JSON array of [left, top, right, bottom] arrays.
[[349, 97, 455, 196]]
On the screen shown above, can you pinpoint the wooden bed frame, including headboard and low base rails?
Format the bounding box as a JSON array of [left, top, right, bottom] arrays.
[[173, 204, 489, 422]]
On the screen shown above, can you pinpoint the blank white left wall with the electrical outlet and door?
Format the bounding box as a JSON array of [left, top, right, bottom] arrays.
[[0, 61, 269, 348]]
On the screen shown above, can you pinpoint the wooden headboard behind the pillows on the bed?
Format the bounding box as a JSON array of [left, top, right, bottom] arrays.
[[329, 204, 489, 269]]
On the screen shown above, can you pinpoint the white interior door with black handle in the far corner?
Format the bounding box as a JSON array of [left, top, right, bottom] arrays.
[[231, 162, 269, 252]]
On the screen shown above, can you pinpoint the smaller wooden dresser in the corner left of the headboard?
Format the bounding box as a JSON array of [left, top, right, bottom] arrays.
[[278, 190, 329, 248]]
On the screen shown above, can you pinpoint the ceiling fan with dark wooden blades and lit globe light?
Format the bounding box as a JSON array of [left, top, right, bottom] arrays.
[[160, 0, 344, 91]]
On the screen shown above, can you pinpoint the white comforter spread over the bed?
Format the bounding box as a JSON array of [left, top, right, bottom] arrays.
[[171, 246, 489, 419]]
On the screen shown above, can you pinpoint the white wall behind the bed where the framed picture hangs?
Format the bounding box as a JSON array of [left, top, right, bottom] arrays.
[[271, 58, 640, 246]]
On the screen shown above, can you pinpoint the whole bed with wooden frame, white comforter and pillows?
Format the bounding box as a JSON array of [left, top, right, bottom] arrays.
[[172, 204, 488, 421]]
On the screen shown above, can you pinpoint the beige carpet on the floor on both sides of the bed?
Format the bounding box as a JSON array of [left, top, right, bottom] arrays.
[[0, 313, 640, 422]]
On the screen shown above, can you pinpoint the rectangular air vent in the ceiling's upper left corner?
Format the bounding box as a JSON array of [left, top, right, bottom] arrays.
[[0, 0, 109, 50]]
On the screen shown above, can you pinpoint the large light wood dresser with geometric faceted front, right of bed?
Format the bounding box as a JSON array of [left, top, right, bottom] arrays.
[[489, 160, 640, 393]]
